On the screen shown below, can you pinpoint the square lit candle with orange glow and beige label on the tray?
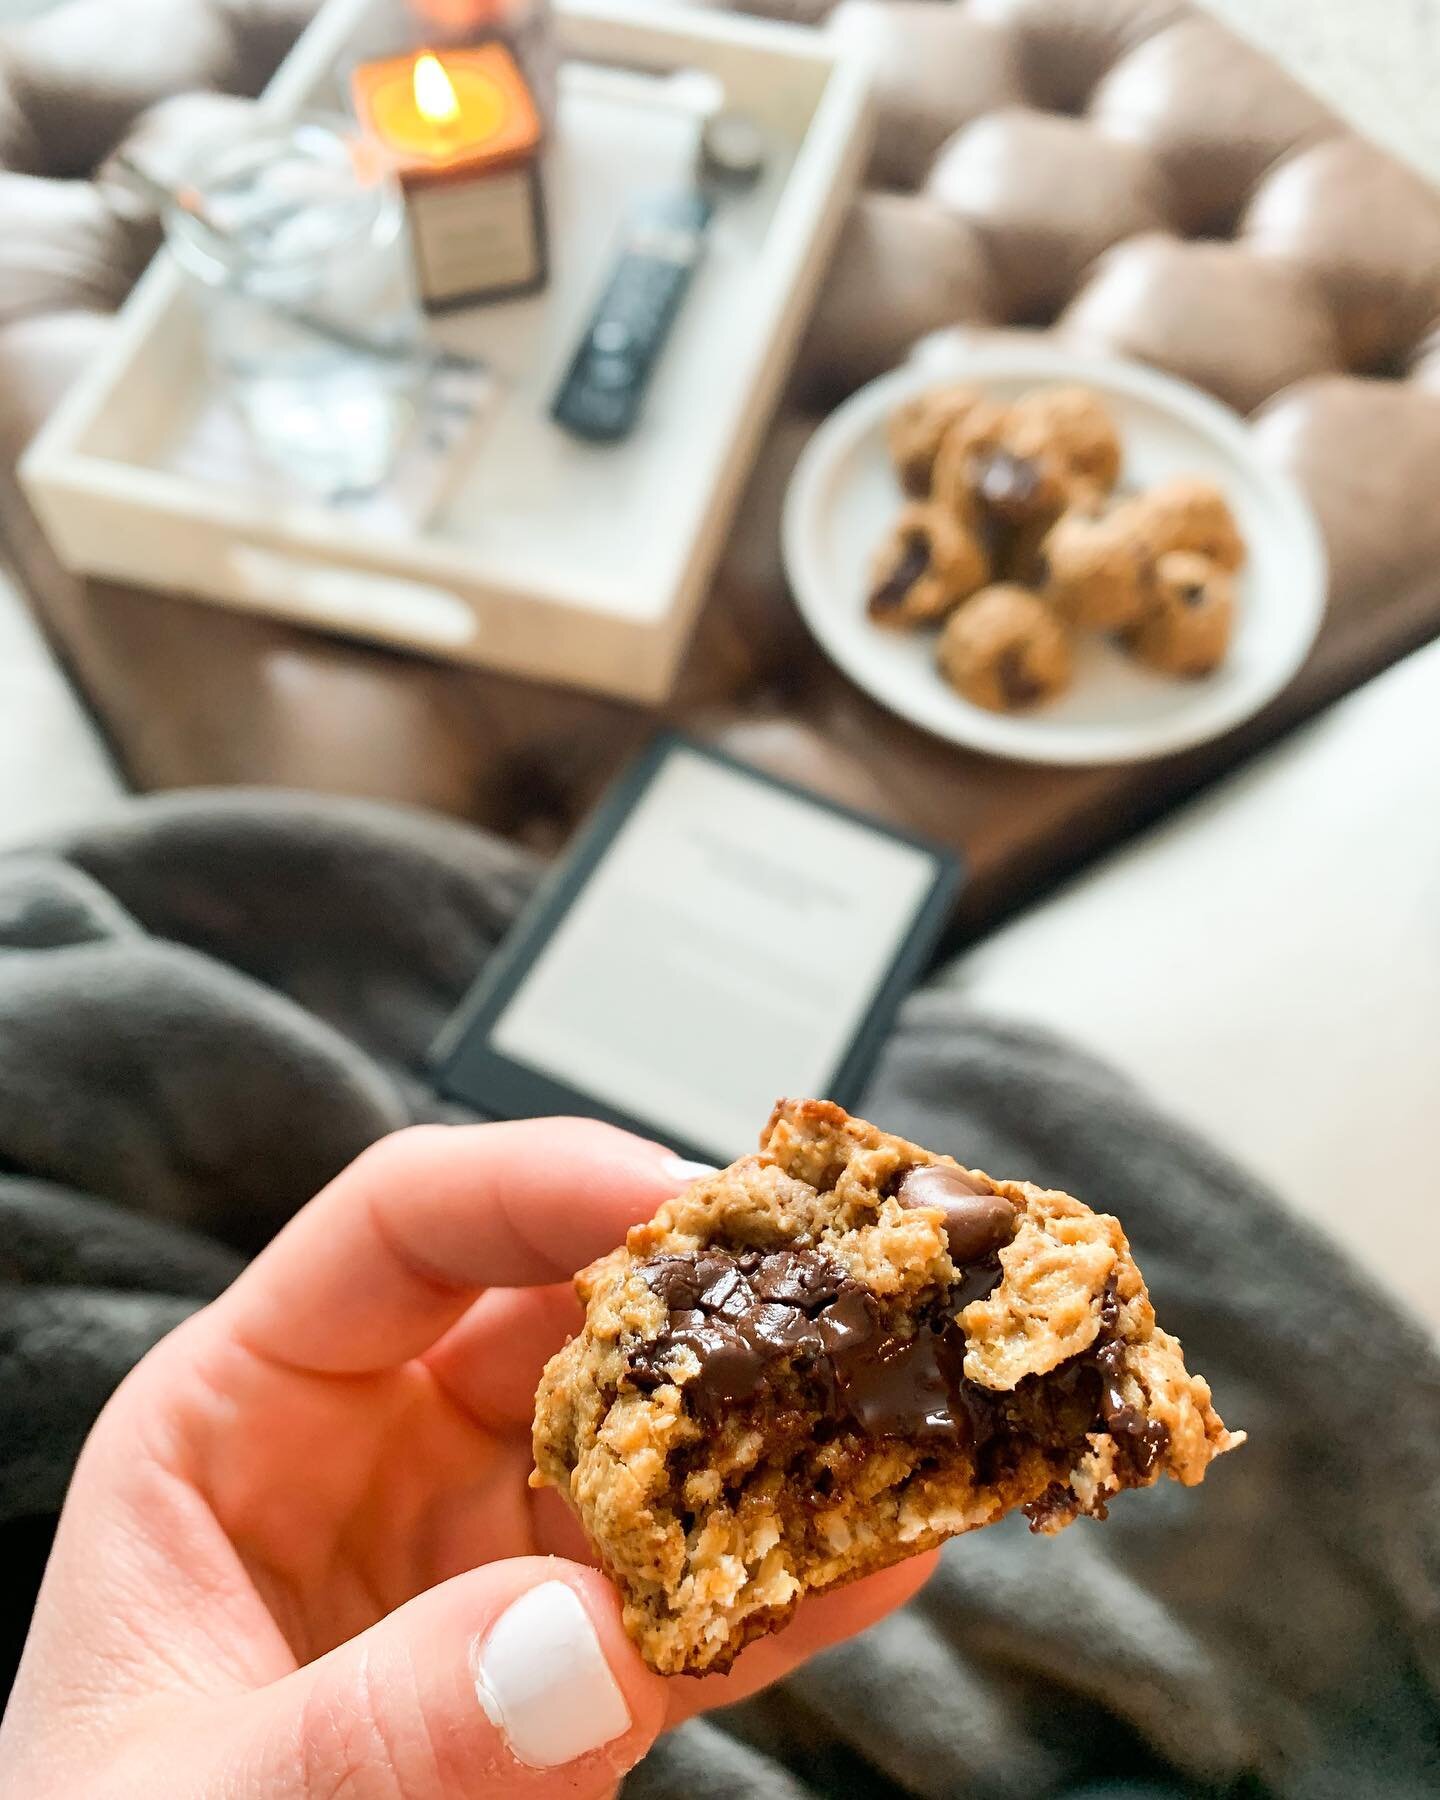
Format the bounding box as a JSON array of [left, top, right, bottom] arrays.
[[353, 41, 545, 308]]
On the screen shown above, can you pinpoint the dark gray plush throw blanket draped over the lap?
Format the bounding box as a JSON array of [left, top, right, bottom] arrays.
[[0, 794, 1440, 1800]]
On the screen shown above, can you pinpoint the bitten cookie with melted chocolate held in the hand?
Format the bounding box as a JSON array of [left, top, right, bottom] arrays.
[[533, 1100, 1242, 1674]]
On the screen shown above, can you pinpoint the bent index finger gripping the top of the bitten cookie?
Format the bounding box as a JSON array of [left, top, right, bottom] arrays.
[[211, 1120, 702, 1375]]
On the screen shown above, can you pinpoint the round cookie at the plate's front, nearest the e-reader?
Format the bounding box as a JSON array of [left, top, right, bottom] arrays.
[[936, 585, 1071, 713]]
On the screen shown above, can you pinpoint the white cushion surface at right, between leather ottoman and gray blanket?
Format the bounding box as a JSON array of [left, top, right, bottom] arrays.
[[945, 643, 1440, 1330]]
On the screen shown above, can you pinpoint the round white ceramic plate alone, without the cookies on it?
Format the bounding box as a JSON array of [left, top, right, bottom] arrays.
[[783, 340, 1327, 763]]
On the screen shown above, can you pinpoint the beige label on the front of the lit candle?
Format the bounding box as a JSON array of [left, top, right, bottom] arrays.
[[407, 169, 540, 304]]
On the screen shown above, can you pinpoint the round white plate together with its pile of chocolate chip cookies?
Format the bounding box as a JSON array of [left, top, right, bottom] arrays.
[[783, 338, 1327, 763]]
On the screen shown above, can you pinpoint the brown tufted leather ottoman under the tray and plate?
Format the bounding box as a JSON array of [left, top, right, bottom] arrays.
[[0, 0, 1440, 929]]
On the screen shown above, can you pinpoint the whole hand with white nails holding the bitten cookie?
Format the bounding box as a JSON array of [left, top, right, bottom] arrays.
[[0, 1120, 931, 1800]]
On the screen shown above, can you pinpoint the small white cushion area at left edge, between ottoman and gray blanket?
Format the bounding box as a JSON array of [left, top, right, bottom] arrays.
[[0, 578, 122, 848]]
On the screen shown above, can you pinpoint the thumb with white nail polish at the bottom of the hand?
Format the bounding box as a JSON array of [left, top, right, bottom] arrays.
[[232, 1557, 666, 1800]]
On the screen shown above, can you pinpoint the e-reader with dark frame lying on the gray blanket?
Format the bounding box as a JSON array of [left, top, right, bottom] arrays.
[[441, 738, 958, 1161]]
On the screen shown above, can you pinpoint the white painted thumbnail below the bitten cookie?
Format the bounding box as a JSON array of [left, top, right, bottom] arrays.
[[475, 1580, 630, 1769]]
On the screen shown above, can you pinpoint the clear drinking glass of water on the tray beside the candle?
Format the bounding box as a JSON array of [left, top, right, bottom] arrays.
[[166, 121, 425, 499]]
